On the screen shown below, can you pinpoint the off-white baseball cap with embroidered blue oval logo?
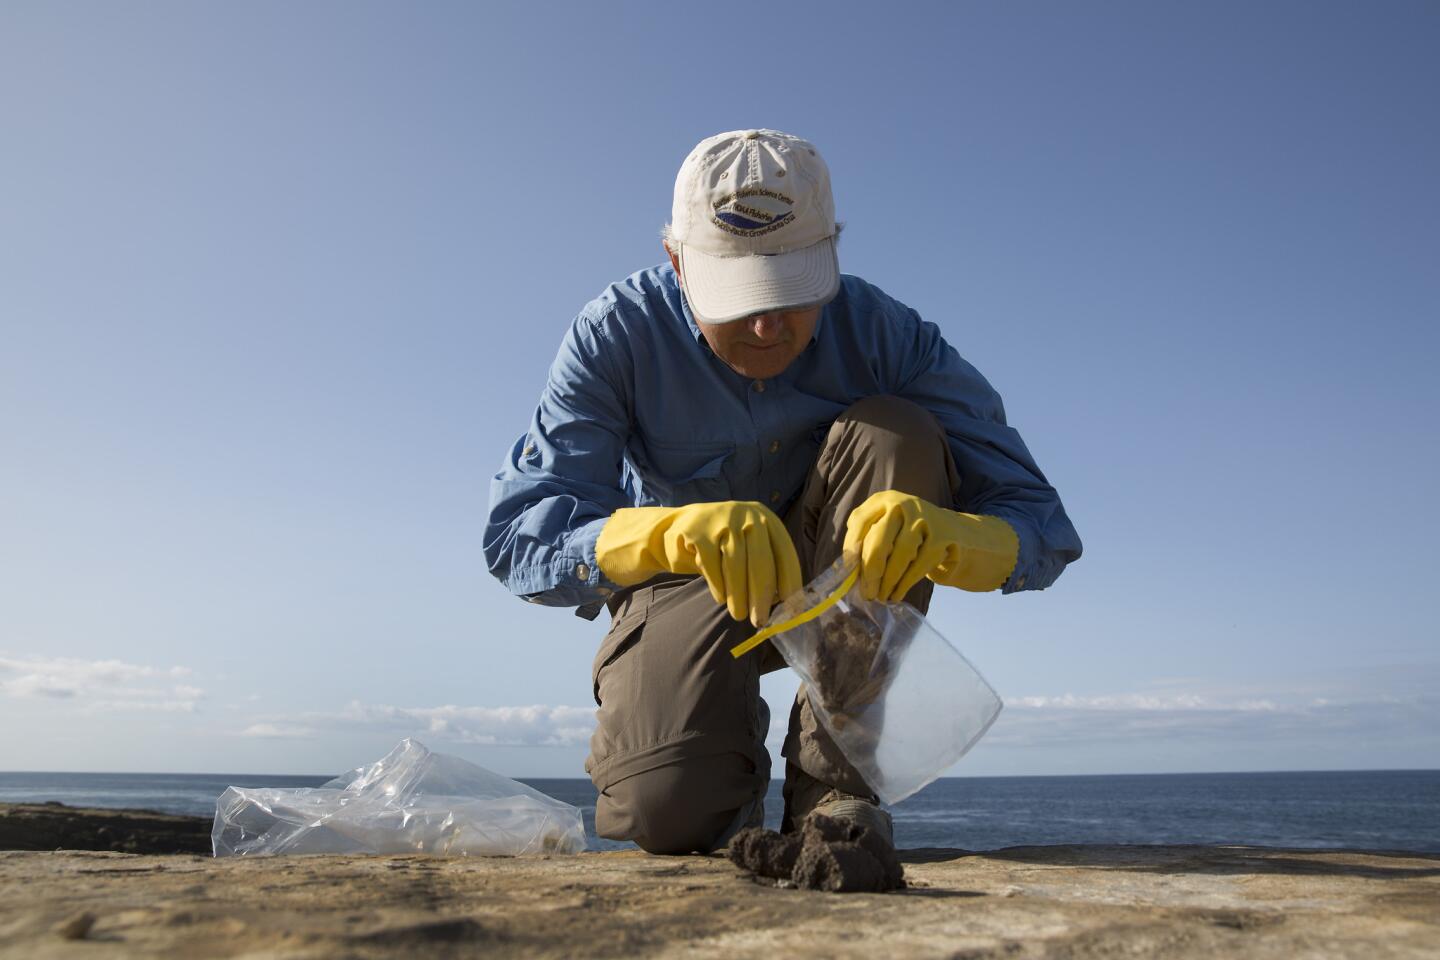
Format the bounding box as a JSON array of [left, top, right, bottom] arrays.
[[670, 130, 840, 324]]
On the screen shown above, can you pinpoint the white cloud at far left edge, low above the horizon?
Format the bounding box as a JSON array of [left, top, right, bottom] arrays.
[[0, 656, 204, 712]]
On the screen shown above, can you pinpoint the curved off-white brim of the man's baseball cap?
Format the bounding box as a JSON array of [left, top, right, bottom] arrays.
[[680, 236, 840, 324]]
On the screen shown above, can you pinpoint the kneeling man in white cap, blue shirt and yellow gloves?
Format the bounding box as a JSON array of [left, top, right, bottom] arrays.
[[485, 130, 1080, 853]]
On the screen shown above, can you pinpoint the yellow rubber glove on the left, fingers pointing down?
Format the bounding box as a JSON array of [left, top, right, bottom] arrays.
[[595, 499, 802, 626]]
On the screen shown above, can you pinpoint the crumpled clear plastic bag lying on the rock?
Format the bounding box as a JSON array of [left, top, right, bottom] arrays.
[[210, 738, 585, 856]]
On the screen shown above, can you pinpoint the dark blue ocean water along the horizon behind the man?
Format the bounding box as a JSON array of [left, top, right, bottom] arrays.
[[0, 770, 1440, 853]]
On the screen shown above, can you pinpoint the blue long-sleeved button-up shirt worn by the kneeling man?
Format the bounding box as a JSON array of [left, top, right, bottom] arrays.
[[485, 263, 1080, 617]]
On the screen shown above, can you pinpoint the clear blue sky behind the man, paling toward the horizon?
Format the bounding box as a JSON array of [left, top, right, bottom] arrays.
[[0, 1, 1440, 776]]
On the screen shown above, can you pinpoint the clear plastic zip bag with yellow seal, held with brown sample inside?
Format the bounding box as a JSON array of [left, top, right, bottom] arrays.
[[730, 557, 1002, 803]]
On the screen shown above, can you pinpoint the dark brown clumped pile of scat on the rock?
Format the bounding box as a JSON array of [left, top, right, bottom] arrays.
[[729, 813, 904, 894]]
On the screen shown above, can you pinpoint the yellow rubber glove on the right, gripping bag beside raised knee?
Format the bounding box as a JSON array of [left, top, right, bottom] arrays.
[[845, 489, 1020, 603]]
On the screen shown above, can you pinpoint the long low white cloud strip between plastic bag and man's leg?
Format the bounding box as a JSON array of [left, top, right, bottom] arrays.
[[240, 701, 595, 747]]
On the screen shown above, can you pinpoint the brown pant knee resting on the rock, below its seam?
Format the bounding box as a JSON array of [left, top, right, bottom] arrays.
[[595, 753, 768, 855]]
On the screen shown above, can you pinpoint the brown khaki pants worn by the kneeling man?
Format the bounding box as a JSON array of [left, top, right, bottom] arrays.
[[585, 396, 959, 853]]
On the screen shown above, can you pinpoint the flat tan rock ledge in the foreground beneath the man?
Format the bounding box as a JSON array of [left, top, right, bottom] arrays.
[[0, 812, 1440, 960]]
